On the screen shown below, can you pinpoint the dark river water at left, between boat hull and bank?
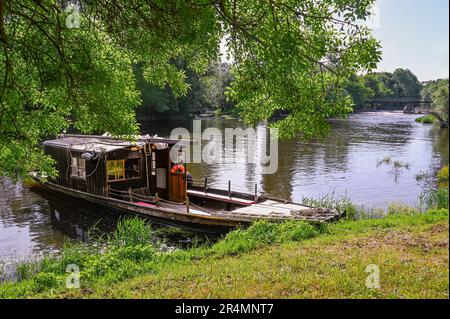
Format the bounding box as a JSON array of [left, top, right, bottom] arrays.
[[0, 178, 116, 257]]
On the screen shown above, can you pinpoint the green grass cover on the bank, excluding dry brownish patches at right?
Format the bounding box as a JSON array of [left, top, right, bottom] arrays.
[[0, 205, 448, 298]]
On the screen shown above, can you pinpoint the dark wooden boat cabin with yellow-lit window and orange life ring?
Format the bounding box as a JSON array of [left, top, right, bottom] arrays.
[[44, 134, 191, 203]]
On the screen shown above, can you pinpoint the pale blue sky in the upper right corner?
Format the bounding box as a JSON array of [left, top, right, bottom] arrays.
[[370, 0, 449, 81]]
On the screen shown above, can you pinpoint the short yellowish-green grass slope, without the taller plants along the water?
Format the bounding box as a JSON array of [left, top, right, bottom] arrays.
[[74, 211, 449, 298]]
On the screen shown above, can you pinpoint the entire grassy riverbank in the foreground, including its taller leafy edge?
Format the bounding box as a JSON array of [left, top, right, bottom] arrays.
[[0, 202, 449, 298]]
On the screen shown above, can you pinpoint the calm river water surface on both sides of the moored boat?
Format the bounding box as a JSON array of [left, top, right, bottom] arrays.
[[0, 112, 449, 261]]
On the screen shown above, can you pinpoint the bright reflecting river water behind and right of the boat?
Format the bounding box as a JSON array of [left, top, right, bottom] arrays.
[[142, 112, 448, 207]]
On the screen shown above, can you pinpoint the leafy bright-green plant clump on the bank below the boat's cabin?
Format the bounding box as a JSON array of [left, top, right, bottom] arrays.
[[0, 217, 157, 293]]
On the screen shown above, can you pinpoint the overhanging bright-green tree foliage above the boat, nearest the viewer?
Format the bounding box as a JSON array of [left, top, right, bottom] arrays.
[[0, 0, 380, 176]]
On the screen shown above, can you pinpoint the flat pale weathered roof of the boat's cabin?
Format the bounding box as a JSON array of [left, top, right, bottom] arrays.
[[43, 134, 192, 153]]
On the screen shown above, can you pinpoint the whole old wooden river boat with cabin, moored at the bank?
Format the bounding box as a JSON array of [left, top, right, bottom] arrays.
[[35, 134, 340, 233]]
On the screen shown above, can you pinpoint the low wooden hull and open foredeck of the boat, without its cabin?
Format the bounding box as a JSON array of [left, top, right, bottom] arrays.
[[38, 182, 342, 233]]
